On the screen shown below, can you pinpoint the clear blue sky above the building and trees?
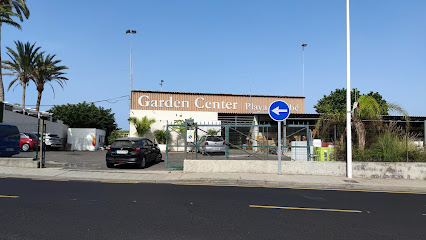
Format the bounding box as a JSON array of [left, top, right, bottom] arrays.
[[1, 0, 426, 129]]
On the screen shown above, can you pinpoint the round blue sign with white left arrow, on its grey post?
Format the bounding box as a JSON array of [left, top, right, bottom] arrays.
[[269, 100, 290, 175]]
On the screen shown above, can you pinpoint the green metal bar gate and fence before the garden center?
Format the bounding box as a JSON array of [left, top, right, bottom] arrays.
[[165, 119, 314, 170]]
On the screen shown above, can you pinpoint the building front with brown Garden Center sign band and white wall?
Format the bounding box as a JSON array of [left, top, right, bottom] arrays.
[[130, 90, 308, 142]]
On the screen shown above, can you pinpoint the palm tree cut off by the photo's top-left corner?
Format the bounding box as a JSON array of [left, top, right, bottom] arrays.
[[0, 0, 30, 102]]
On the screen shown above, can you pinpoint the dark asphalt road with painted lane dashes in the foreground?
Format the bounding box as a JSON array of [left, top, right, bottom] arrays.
[[0, 179, 426, 240]]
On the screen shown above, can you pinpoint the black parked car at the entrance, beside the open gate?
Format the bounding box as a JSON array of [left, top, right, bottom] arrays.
[[106, 137, 162, 168]]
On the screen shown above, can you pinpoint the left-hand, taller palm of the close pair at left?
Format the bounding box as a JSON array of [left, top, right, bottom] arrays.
[[3, 41, 40, 107]]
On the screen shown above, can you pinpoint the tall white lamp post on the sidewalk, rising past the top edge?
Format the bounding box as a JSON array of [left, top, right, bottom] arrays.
[[346, 0, 352, 178]]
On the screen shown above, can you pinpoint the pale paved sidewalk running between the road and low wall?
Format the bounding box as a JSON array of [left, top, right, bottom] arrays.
[[0, 167, 426, 194]]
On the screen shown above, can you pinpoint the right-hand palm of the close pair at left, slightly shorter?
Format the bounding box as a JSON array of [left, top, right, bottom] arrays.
[[33, 53, 68, 111]]
